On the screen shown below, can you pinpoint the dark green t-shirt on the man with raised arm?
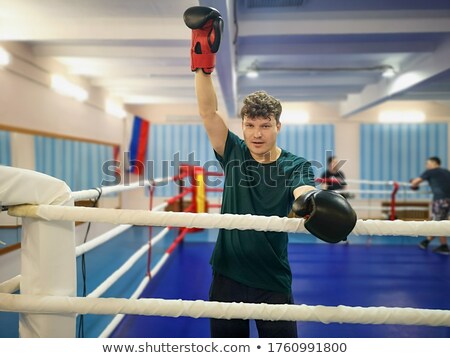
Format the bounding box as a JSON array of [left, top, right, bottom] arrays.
[[210, 131, 314, 293]]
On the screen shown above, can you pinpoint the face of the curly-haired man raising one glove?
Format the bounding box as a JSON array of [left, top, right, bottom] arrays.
[[242, 116, 281, 157]]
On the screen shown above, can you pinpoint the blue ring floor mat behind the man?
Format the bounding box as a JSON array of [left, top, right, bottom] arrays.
[[112, 242, 450, 338]]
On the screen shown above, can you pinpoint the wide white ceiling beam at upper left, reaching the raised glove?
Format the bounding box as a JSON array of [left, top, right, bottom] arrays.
[[0, 15, 190, 41]]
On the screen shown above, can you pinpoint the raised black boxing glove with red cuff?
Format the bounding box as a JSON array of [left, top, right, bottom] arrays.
[[183, 6, 223, 74]]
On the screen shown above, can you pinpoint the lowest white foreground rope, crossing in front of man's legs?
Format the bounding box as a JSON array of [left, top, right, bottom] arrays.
[[0, 293, 450, 327]]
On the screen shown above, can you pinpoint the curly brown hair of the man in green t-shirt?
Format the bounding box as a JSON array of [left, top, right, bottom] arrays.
[[241, 91, 282, 123]]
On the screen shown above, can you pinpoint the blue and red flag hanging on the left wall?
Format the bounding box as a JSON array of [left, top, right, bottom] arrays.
[[128, 116, 150, 175]]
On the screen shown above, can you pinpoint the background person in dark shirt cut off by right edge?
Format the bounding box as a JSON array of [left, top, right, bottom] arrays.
[[411, 157, 450, 255]]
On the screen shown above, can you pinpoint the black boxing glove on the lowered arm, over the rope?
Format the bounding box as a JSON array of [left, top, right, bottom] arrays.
[[292, 190, 357, 244]]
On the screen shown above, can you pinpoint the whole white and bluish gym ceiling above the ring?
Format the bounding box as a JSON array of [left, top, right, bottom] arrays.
[[0, 0, 450, 118]]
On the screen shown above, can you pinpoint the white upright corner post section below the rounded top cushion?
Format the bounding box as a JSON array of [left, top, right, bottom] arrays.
[[19, 200, 77, 338]]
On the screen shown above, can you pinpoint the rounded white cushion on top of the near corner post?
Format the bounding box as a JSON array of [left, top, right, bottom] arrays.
[[0, 165, 71, 206]]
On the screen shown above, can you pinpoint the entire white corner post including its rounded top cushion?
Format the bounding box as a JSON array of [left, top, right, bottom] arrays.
[[0, 166, 77, 338]]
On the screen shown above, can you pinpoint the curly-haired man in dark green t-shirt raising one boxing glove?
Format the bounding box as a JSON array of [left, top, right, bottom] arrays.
[[184, 6, 356, 337]]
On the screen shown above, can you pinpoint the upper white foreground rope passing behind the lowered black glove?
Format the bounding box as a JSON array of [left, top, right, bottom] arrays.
[[8, 205, 450, 236]]
